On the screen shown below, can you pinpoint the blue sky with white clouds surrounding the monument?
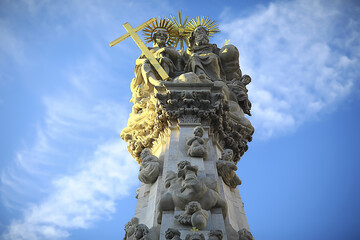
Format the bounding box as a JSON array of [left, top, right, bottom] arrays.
[[0, 0, 360, 240]]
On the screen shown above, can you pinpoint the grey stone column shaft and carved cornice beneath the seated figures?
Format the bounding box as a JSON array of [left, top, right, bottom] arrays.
[[126, 83, 252, 240]]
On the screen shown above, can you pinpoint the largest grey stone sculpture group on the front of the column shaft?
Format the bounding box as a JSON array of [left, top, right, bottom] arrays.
[[157, 161, 227, 223]]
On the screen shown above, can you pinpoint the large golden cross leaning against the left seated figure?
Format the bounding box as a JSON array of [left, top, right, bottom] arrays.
[[109, 18, 169, 80]]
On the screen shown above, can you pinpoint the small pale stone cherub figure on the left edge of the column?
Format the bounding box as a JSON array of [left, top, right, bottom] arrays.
[[138, 148, 160, 184]]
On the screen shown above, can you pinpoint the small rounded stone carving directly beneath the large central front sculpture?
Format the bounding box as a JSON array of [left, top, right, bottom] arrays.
[[175, 201, 209, 230]]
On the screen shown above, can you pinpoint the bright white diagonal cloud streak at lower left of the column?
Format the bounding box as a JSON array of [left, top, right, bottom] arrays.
[[3, 139, 138, 240]]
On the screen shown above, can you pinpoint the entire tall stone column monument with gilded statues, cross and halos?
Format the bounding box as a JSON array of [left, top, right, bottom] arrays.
[[113, 13, 254, 240]]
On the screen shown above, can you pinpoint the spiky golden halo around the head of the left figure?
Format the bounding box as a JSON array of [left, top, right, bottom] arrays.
[[143, 17, 175, 46]]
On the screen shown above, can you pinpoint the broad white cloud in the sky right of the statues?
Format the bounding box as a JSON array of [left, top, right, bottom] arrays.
[[220, 0, 360, 138]]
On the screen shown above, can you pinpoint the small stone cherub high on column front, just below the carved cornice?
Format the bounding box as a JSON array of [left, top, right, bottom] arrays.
[[186, 126, 207, 157]]
